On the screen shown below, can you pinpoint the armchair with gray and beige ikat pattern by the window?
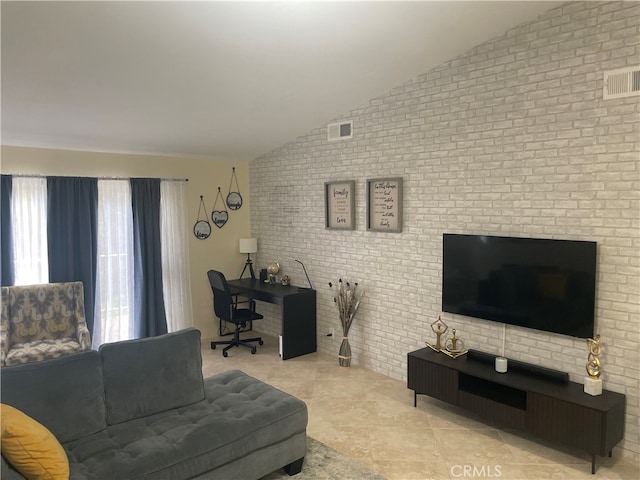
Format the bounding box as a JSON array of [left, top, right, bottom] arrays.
[[0, 282, 91, 366]]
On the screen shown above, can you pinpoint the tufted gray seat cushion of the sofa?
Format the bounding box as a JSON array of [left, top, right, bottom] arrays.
[[65, 370, 307, 480]]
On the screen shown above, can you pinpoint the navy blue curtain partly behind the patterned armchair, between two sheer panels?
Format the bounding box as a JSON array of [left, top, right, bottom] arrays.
[[47, 177, 98, 334]]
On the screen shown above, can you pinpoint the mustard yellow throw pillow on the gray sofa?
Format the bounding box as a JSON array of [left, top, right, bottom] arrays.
[[0, 404, 69, 480]]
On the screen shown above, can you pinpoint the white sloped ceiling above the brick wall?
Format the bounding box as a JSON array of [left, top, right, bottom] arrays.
[[1, 1, 561, 161]]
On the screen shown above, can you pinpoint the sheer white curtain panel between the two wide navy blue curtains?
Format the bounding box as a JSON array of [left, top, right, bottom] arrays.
[[92, 179, 133, 348]]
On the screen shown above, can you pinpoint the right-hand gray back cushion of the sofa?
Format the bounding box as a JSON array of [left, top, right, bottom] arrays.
[[99, 328, 204, 425]]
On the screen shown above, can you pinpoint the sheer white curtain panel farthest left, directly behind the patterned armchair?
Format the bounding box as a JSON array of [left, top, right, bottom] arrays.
[[11, 176, 49, 285]]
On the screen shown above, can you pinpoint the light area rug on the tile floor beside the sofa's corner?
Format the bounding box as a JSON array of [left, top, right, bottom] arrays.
[[260, 437, 385, 480]]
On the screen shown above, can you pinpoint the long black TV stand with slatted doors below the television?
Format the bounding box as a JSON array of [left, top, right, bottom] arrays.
[[407, 348, 626, 473]]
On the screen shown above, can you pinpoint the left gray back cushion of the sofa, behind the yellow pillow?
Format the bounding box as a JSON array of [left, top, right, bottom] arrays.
[[0, 351, 106, 443]]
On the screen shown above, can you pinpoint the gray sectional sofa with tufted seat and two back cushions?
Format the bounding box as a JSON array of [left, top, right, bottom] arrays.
[[0, 329, 308, 480]]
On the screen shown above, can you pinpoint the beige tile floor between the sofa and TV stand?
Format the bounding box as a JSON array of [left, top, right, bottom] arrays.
[[202, 332, 640, 480]]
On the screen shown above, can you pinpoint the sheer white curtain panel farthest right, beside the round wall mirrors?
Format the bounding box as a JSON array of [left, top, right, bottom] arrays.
[[160, 181, 193, 332]]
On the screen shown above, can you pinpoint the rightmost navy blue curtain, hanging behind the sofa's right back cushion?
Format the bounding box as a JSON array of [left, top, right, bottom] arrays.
[[131, 178, 167, 338]]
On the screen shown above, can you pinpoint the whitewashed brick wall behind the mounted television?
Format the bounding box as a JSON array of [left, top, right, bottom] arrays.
[[250, 2, 640, 458]]
